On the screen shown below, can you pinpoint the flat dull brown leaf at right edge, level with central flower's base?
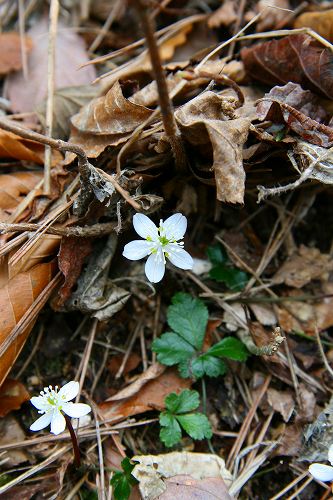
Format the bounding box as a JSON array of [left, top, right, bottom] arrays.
[[273, 245, 333, 288]]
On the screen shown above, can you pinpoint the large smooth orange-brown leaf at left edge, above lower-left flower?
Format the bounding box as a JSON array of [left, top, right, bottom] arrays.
[[0, 263, 57, 385]]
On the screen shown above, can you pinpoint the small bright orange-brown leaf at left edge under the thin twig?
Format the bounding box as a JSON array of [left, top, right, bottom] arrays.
[[0, 129, 45, 165]]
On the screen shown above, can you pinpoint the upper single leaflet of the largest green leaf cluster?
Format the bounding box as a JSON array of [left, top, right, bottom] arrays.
[[167, 292, 208, 349]]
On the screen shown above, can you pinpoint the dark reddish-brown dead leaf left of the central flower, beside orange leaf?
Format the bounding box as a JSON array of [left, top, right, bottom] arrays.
[[57, 237, 92, 307]]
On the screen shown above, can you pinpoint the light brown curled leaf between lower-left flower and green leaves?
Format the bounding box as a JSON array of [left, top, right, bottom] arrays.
[[99, 365, 191, 422]]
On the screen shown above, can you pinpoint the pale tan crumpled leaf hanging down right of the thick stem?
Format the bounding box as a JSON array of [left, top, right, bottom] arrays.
[[175, 92, 251, 203]]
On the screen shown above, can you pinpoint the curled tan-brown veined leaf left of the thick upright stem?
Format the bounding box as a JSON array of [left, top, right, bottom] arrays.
[[66, 82, 153, 161]]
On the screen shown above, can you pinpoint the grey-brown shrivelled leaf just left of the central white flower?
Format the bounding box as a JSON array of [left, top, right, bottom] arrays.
[[65, 234, 130, 321]]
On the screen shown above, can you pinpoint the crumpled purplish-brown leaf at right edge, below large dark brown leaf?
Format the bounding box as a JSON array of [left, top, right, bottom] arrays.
[[257, 82, 333, 147]]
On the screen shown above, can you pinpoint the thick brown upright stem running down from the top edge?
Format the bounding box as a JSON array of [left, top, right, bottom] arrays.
[[133, 0, 186, 170]]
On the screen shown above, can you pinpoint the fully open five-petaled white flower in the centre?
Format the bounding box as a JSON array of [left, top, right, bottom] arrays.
[[123, 214, 193, 283]]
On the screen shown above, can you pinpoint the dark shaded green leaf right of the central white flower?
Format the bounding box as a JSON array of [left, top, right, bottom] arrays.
[[207, 245, 249, 292]]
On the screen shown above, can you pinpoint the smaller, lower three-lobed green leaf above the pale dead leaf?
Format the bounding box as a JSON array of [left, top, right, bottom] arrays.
[[160, 389, 213, 447]]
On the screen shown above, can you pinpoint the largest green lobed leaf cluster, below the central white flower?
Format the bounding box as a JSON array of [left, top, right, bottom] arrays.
[[152, 292, 248, 379]]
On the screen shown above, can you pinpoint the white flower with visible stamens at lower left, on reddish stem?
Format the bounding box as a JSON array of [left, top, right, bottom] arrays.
[[30, 381, 91, 434]]
